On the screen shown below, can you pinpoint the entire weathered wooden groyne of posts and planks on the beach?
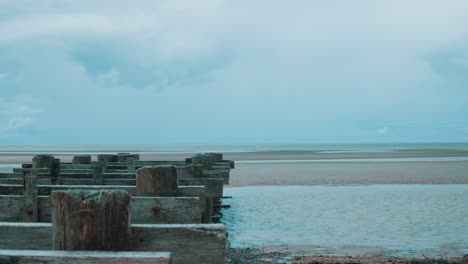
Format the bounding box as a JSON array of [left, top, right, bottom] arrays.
[[0, 153, 234, 263]]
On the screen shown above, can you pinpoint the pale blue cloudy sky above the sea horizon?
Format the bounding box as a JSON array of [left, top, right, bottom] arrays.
[[0, 0, 468, 144]]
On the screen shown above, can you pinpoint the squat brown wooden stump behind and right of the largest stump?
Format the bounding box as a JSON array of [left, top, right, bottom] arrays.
[[136, 165, 178, 196]]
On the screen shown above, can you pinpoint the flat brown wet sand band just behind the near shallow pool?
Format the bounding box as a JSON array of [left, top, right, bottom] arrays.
[[230, 161, 468, 186]]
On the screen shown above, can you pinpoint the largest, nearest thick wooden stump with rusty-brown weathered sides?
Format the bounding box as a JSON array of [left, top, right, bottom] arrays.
[[50, 190, 131, 250]]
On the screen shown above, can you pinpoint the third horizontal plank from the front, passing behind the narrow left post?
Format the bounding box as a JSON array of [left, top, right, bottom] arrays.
[[0, 195, 200, 224]]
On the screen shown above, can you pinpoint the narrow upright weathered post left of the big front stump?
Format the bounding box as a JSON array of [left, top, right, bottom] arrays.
[[23, 169, 39, 222]]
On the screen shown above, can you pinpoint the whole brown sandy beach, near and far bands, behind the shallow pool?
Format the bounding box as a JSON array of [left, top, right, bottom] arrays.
[[0, 149, 468, 186]]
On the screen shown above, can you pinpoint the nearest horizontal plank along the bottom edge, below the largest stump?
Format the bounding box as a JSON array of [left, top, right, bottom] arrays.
[[0, 250, 171, 264]]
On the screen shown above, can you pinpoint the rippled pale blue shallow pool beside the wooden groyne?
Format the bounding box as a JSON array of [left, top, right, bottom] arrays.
[[223, 185, 468, 253]]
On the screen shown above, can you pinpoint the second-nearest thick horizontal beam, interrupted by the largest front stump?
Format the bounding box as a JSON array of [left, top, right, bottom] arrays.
[[0, 222, 226, 264]]
